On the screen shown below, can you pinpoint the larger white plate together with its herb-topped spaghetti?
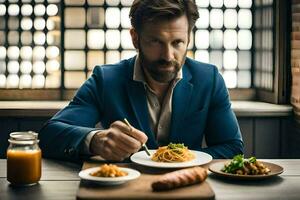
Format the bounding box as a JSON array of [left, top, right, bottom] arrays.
[[130, 143, 212, 168]]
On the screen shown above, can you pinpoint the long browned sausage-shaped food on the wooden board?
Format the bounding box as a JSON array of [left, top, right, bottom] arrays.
[[151, 167, 207, 191]]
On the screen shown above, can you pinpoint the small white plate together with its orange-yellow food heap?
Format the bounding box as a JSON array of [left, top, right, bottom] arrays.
[[78, 164, 141, 185]]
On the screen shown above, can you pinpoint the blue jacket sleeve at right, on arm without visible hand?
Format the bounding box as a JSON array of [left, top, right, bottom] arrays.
[[202, 68, 244, 158]]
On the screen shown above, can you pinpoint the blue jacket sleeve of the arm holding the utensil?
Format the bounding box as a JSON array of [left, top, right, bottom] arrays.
[[39, 67, 103, 161]]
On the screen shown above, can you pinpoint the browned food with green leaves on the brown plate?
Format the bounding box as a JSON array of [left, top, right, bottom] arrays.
[[221, 155, 271, 175]]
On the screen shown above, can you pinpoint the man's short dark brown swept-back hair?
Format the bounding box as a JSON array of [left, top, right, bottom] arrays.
[[129, 0, 199, 33]]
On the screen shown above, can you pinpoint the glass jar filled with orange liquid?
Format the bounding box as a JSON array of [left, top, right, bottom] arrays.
[[7, 131, 42, 185]]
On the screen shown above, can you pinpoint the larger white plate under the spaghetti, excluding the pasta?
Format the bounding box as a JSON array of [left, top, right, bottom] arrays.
[[130, 150, 212, 168]]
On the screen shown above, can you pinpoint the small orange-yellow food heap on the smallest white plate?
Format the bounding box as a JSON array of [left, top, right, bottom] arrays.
[[90, 164, 128, 177]]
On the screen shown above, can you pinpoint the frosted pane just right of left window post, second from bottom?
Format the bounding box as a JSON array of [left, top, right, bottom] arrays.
[[65, 51, 85, 70]]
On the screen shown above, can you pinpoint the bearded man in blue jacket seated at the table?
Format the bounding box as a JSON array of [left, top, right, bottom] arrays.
[[39, 0, 243, 161]]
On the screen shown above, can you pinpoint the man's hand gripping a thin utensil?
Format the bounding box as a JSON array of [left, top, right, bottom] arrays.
[[90, 121, 148, 161]]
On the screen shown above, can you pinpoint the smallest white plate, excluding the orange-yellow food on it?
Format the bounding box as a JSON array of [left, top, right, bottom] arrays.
[[78, 167, 141, 185]]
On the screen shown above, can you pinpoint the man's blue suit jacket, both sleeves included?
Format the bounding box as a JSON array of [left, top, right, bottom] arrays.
[[39, 57, 243, 161]]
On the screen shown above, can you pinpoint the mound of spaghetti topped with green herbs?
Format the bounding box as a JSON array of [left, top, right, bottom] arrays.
[[151, 143, 195, 162]]
